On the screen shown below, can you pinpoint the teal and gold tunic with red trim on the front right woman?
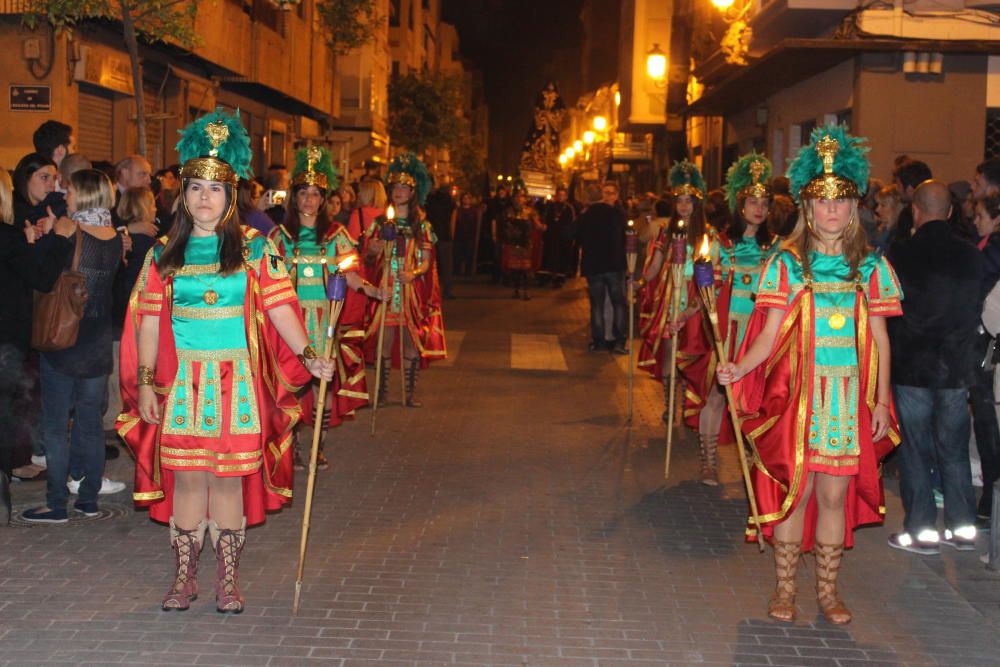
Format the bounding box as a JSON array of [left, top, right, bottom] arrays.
[[757, 250, 902, 475]]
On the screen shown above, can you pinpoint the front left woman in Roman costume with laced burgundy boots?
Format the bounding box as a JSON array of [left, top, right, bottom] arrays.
[[118, 110, 334, 613]]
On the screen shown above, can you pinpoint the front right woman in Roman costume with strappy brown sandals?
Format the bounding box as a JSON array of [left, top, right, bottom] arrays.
[[719, 126, 902, 624]]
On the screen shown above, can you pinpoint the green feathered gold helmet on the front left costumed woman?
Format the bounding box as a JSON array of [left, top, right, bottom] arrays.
[[177, 108, 253, 187]]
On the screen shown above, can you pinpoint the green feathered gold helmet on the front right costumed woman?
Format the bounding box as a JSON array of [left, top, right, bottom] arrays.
[[786, 125, 871, 201]]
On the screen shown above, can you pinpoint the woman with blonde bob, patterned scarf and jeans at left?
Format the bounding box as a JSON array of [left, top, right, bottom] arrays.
[[23, 169, 122, 523]]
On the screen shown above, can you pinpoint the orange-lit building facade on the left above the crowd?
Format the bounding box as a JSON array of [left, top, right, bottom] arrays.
[[0, 0, 376, 174]]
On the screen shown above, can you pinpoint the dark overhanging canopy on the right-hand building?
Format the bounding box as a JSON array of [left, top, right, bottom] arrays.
[[685, 38, 1000, 116]]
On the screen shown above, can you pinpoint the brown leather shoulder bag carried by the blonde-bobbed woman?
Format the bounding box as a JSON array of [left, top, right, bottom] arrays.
[[31, 227, 87, 352]]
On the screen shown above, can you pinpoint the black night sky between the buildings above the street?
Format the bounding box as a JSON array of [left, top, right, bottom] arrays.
[[443, 0, 584, 173]]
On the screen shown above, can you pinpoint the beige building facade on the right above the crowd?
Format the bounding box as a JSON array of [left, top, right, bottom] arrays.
[[687, 0, 1000, 186]]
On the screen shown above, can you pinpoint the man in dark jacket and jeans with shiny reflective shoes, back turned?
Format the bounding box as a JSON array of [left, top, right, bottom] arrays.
[[889, 180, 983, 555]]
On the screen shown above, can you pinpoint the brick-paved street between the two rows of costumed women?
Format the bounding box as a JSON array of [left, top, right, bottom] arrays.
[[0, 284, 1000, 667]]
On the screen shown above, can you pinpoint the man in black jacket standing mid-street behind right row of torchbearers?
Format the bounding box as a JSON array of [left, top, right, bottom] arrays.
[[576, 181, 628, 354]]
